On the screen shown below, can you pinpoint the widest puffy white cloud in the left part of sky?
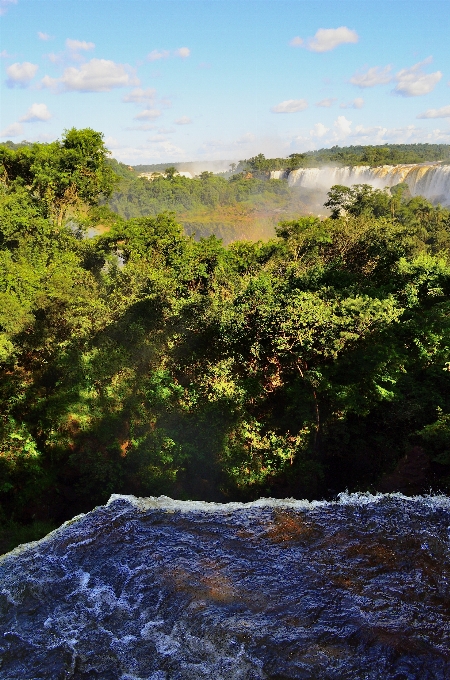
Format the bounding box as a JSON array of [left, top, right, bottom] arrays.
[[42, 59, 139, 92]]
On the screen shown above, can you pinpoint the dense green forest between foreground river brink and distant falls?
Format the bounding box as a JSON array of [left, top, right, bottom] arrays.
[[0, 129, 450, 552]]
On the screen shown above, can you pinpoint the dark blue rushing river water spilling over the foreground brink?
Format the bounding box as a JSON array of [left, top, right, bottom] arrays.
[[0, 494, 450, 680]]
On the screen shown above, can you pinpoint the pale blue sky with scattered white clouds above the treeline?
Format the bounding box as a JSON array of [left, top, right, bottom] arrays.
[[0, 0, 450, 164]]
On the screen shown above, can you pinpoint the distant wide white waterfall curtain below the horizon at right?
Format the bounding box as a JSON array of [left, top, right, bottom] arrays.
[[270, 163, 450, 206]]
